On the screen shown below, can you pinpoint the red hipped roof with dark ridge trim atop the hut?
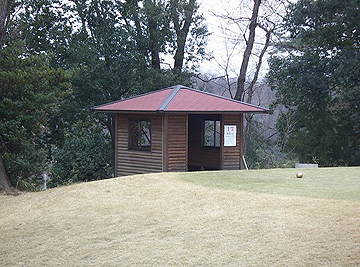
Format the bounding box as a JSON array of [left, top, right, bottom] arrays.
[[93, 85, 267, 113]]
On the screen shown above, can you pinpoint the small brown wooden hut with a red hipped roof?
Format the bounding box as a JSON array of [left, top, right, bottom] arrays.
[[93, 85, 267, 176]]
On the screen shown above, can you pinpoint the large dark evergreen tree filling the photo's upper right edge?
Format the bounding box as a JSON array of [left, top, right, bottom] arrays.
[[269, 0, 360, 166]]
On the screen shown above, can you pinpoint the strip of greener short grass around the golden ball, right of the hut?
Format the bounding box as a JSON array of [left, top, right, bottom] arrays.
[[177, 167, 360, 201]]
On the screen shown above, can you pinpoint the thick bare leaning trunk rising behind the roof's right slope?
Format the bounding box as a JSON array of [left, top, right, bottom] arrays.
[[235, 0, 261, 100]]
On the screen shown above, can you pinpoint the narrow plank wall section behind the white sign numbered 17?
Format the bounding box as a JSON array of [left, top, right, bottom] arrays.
[[222, 114, 243, 170]]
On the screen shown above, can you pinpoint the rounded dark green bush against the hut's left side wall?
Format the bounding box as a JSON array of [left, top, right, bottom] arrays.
[[49, 122, 112, 186]]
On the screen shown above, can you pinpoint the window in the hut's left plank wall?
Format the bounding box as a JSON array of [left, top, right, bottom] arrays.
[[129, 120, 151, 150]]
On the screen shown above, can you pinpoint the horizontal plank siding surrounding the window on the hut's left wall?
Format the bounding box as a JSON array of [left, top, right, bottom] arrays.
[[116, 114, 163, 176]]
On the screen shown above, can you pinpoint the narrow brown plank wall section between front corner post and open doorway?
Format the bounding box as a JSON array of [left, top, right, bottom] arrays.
[[165, 114, 188, 172]]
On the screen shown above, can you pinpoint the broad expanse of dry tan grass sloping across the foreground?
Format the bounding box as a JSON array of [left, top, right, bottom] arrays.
[[0, 174, 360, 266]]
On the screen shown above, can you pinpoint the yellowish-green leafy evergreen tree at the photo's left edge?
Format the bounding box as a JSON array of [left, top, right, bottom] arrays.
[[0, 43, 70, 189]]
